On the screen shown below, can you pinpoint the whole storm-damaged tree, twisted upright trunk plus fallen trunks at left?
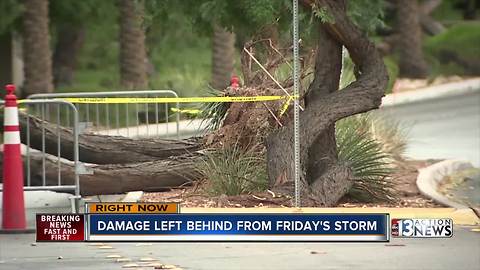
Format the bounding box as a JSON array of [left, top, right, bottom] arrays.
[[1, 0, 388, 206]]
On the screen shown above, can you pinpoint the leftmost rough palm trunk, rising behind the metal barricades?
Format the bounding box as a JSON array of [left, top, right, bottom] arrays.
[[22, 0, 53, 96]]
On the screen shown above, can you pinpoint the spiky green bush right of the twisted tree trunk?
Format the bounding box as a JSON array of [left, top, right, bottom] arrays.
[[336, 114, 406, 201]]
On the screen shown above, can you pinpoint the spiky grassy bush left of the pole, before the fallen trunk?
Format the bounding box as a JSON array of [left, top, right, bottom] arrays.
[[197, 145, 268, 196]]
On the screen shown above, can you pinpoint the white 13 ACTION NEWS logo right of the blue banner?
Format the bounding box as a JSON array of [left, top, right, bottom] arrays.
[[391, 218, 453, 238]]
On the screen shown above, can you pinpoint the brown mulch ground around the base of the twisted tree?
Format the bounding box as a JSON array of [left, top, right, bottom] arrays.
[[141, 160, 442, 208]]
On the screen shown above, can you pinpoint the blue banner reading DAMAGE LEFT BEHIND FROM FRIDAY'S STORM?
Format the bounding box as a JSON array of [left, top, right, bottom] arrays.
[[86, 214, 389, 242]]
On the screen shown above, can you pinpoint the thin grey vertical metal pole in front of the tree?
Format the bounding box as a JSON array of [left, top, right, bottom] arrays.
[[293, 0, 301, 207]]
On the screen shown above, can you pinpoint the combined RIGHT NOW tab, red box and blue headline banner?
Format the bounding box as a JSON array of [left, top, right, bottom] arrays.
[[37, 203, 390, 242]]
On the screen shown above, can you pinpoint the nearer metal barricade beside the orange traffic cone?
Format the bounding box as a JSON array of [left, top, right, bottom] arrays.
[[0, 99, 81, 212]]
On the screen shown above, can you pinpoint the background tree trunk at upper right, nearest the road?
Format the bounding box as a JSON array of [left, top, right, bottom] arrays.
[[396, 0, 428, 78]]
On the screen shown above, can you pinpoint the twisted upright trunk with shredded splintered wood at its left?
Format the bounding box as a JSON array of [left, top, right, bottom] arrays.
[[202, 0, 388, 206]]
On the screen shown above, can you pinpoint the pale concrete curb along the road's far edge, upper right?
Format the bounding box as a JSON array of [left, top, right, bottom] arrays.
[[381, 78, 480, 107]]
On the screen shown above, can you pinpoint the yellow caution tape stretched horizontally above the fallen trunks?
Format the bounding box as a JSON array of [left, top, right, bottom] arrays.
[[60, 96, 287, 104]]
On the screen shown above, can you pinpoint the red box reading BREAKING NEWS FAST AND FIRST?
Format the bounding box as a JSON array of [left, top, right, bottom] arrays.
[[37, 214, 85, 242]]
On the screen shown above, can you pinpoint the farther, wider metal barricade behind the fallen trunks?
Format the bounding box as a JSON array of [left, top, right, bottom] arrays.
[[28, 90, 180, 138]]
